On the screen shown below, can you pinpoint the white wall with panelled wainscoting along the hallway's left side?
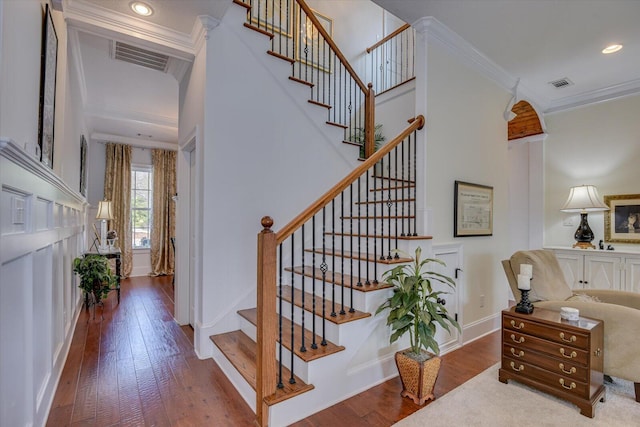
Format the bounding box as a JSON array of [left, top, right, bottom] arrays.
[[0, 0, 86, 426]]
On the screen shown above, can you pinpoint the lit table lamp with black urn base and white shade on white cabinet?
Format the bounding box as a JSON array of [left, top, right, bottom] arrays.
[[560, 185, 609, 249]]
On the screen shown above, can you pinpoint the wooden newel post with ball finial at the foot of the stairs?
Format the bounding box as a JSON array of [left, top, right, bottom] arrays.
[[256, 216, 277, 426]]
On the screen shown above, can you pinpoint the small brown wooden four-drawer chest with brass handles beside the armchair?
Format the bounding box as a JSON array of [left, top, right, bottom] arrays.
[[498, 307, 605, 417]]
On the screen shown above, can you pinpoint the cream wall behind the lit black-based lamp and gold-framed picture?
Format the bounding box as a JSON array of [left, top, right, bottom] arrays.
[[544, 95, 640, 248]]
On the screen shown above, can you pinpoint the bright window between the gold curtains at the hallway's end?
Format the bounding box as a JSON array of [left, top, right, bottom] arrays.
[[131, 166, 153, 249]]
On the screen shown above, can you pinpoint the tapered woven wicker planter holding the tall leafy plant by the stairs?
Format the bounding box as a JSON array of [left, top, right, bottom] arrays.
[[396, 350, 441, 405]]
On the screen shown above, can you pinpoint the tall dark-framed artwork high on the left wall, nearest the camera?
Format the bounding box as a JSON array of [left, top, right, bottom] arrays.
[[38, 4, 58, 168]]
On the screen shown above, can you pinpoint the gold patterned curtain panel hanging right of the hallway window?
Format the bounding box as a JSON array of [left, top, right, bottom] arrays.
[[151, 149, 176, 276]]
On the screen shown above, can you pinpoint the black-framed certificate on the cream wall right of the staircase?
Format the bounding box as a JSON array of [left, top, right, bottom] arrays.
[[453, 181, 493, 237]]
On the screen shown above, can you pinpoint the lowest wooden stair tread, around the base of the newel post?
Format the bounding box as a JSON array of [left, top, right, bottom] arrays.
[[209, 331, 314, 405]]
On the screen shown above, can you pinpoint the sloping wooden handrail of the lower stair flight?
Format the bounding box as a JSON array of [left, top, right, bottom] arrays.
[[276, 115, 425, 244]]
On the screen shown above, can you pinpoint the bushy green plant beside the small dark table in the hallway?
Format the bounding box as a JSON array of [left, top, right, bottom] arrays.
[[73, 254, 117, 304]]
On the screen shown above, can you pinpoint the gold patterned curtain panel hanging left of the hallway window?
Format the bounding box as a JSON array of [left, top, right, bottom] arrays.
[[104, 142, 133, 277]]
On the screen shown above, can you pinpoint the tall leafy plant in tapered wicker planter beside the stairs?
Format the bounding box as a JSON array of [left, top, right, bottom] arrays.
[[376, 247, 460, 405]]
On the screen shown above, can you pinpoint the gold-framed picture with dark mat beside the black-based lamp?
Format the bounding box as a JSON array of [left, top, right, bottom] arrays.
[[604, 194, 640, 243]]
